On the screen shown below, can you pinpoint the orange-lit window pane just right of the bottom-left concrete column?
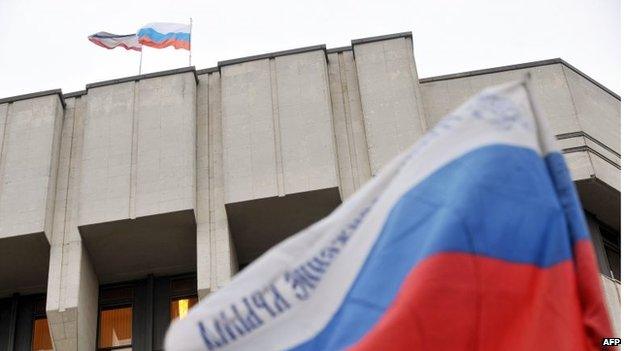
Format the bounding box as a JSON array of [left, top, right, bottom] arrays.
[[98, 306, 132, 350]]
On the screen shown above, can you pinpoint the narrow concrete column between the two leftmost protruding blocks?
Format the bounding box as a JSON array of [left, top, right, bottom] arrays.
[[46, 97, 99, 351]]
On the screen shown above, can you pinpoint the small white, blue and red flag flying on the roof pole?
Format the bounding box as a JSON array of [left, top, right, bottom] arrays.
[[137, 23, 191, 50]]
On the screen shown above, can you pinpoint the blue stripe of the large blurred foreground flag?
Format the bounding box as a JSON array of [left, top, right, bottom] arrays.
[[292, 145, 588, 351]]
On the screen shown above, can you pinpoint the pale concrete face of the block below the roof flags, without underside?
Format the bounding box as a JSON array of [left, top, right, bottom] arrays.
[[79, 73, 196, 225]]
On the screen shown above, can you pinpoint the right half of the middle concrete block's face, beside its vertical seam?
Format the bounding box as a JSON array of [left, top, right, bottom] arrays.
[[274, 50, 338, 194]]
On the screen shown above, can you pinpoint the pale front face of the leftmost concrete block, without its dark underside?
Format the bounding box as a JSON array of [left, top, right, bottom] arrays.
[[0, 95, 62, 240]]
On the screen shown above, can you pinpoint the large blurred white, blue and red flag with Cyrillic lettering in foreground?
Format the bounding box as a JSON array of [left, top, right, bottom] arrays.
[[166, 82, 611, 351]]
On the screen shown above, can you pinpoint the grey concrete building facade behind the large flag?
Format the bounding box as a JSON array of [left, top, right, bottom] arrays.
[[0, 33, 620, 351]]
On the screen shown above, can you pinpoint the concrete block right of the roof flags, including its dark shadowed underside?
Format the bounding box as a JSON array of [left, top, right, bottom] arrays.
[[221, 46, 340, 266]]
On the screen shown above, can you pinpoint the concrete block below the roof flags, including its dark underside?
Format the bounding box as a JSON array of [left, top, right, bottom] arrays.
[[77, 68, 197, 283]]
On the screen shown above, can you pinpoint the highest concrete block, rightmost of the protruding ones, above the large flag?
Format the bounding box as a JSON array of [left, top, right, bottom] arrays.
[[352, 33, 427, 175]]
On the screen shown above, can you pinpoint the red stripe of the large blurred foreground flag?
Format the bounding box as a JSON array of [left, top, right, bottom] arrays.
[[351, 240, 613, 351]]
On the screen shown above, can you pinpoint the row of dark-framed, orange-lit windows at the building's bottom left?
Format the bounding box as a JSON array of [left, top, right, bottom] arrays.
[[0, 275, 197, 351]]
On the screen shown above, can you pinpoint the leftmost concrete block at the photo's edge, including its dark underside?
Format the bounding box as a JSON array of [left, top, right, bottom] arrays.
[[0, 94, 63, 296]]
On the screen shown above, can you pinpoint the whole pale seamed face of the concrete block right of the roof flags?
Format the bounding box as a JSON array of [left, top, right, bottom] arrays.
[[221, 50, 338, 203]]
